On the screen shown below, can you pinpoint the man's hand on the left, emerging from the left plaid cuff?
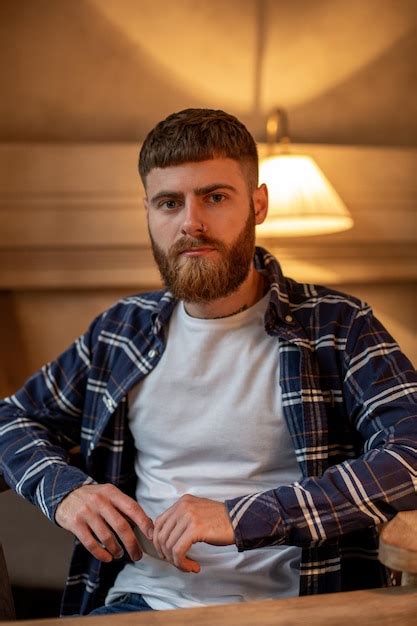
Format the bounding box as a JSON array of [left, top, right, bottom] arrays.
[[55, 484, 153, 563]]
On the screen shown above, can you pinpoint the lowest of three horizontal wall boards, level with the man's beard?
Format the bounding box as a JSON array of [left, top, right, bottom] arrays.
[[0, 240, 417, 291]]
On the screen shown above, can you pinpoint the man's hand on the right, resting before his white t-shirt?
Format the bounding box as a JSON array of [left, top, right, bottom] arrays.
[[152, 494, 235, 573]]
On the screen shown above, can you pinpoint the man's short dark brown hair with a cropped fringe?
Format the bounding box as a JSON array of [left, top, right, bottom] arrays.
[[139, 109, 258, 192]]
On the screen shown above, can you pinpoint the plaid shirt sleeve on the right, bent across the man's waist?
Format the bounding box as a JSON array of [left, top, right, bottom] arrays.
[[226, 309, 417, 551]]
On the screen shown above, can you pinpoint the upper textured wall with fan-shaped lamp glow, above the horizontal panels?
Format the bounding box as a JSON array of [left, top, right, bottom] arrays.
[[0, 0, 417, 145]]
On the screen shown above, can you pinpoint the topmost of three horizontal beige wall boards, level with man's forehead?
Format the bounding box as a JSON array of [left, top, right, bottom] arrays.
[[0, 143, 417, 202]]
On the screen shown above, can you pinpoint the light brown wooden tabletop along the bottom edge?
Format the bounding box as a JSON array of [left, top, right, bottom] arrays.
[[1, 587, 417, 626]]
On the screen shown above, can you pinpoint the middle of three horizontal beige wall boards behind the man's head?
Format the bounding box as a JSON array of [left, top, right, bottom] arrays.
[[0, 203, 417, 249]]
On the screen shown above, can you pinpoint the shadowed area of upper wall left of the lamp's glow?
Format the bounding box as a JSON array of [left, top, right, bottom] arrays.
[[0, 0, 203, 141]]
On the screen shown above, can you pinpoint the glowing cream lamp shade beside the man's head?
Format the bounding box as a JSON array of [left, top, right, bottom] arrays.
[[257, 154, 353, 237]]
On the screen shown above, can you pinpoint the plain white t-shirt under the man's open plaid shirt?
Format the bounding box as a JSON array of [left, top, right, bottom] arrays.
[[106, 295, 301, 609]]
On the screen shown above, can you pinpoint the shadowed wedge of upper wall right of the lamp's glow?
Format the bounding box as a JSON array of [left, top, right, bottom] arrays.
[[291, 30, 417, 146]]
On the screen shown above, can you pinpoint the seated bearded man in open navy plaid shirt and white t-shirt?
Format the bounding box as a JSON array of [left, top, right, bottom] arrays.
[[0, 109, 417, 614]]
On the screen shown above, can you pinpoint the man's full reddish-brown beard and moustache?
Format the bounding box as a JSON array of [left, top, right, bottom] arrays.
[[149, 202, 255, 303]]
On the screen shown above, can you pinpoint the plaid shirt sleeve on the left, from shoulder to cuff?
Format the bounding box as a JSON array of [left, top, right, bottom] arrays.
[[0, 318, 103, 521]]
